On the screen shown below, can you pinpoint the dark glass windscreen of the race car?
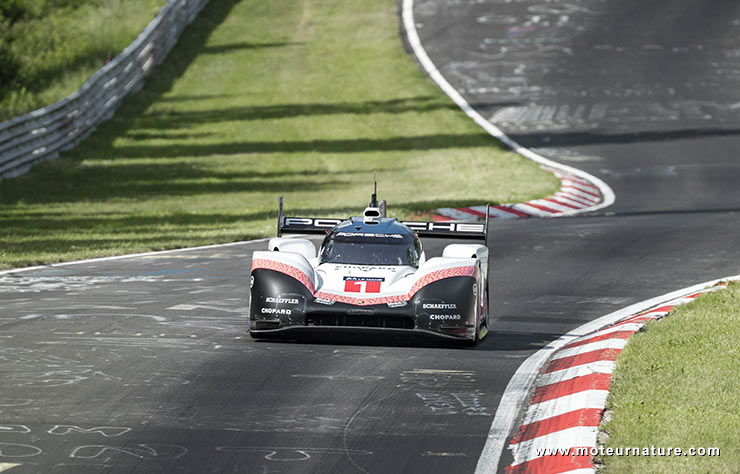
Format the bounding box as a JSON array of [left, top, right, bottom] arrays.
[[320, 232, 419, 267]]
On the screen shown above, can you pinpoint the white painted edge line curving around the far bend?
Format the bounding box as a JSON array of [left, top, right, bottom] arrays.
[[402, 0, 615, 216]]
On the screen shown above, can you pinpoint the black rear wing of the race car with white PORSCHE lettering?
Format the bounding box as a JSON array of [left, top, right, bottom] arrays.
[[277, 197, 490, 243]]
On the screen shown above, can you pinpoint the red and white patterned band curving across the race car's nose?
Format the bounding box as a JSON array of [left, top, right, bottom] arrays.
[[252, 258, 477, 306]]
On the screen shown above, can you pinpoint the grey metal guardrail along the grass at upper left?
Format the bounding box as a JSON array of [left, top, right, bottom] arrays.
[[0, 0, 208, 179]]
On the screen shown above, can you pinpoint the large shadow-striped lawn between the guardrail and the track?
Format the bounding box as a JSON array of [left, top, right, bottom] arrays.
[[0, 0, 559, 268]]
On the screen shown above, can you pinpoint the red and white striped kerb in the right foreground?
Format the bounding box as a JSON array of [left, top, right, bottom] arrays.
[[506, 283, 727, 474]]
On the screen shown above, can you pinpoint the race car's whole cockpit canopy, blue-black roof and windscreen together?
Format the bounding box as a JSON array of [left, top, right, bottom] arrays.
[[319, 217, 422, 267]]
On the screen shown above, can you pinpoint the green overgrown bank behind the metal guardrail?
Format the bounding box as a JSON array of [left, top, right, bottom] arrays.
[[0, 0, 166, 121]]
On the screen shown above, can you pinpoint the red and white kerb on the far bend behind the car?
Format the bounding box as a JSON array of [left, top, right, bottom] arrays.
[[431, 166, 603, 221]]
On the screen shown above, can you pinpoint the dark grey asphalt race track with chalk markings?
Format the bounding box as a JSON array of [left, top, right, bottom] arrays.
[[0, 0, 740, 474]]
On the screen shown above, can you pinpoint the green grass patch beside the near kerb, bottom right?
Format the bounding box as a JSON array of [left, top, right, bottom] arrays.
[[600, 284, 740, 474]]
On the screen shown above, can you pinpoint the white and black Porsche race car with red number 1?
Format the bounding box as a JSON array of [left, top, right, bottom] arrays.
[[249, 194, 488, 344]]
